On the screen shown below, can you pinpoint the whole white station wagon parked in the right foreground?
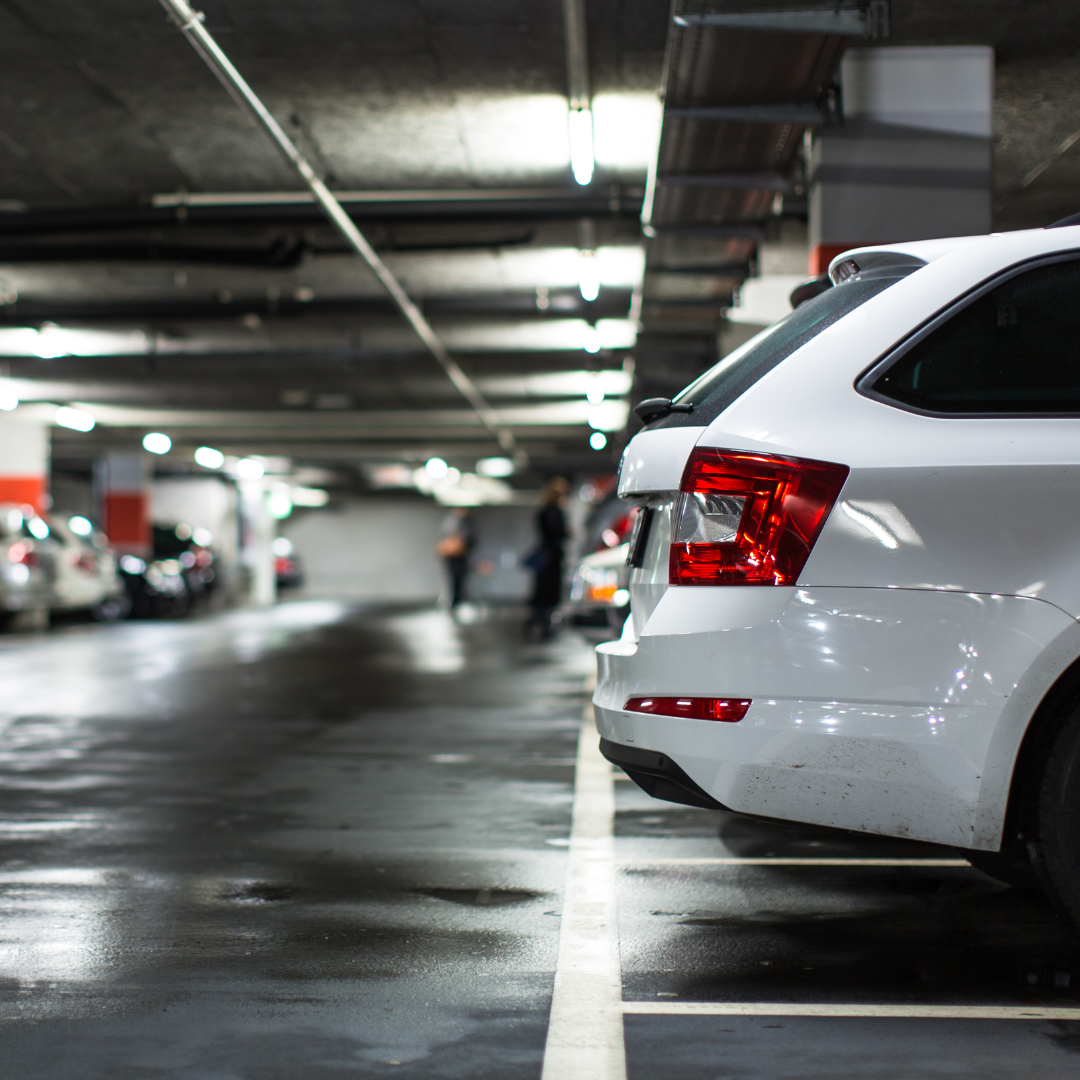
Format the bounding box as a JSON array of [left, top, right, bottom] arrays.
[[593, 226, 1080, 921]]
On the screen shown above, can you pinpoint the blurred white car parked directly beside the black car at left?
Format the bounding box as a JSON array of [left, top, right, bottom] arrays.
[[44, 514, 131, 622]]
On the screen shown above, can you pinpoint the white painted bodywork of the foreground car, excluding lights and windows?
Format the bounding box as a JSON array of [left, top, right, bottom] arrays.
[[594, 227, 1080, 850]]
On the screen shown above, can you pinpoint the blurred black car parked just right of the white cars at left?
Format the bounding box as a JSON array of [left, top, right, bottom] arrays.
[[120, 523, 219, 619]]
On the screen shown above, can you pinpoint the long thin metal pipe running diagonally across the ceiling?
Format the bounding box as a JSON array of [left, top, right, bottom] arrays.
[[154, 0, 525, 463]]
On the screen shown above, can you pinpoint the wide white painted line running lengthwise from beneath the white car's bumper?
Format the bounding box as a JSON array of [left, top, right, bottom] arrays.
[[542, 710, 626, 1080]]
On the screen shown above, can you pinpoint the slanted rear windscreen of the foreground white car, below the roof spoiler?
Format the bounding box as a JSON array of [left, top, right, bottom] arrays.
[[648, 260, 922, 431]]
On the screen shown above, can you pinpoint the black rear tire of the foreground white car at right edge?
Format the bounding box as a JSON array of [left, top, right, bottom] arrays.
[[1029, 702, 1080, 928]]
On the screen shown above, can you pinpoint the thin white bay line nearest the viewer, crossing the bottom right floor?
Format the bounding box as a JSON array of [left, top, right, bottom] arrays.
[[622, 1001, 1080, 1021]]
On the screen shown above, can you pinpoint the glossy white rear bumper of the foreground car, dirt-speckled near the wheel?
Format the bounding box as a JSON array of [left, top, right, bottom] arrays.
[[593, 588, 1080, 849]]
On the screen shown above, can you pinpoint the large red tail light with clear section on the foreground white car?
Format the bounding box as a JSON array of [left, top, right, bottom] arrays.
[[670, 447, 849, 585]]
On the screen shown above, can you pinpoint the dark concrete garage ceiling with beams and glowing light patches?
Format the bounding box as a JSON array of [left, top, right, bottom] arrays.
[[0, 0, 1080, 481]]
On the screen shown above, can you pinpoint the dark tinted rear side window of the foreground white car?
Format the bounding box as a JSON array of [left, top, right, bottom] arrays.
[[860, 258, 1080, 416]]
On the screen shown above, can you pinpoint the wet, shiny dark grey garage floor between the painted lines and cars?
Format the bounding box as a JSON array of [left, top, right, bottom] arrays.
[[0, 600, 1080, 1080]]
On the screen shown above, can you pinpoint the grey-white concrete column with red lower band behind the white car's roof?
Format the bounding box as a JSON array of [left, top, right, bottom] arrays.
[[808, 45, 994, 274]]
